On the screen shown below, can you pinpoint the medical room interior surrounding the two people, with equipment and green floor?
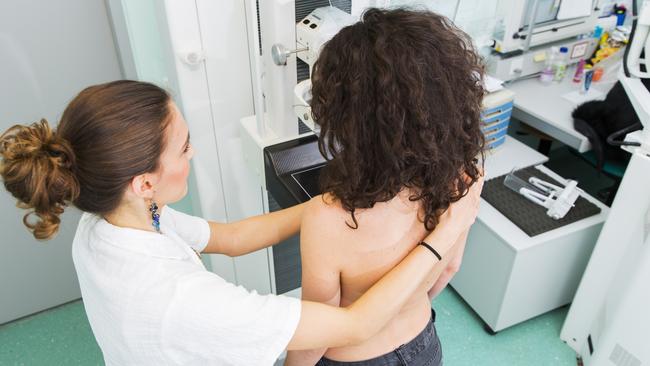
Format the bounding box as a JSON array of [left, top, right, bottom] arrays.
[[0, 0, 650, 366]]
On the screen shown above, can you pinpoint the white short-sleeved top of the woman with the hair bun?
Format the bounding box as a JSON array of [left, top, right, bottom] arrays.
[[72, 207, 300, 365]]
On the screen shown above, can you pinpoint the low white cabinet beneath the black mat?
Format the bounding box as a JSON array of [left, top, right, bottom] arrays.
[[451, 167, 609, 332]]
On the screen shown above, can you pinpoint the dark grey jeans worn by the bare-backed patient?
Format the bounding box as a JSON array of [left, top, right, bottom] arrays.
[[316, 309, 442, 366]]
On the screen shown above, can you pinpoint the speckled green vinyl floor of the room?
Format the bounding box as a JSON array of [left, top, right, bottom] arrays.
[[0, 288, 576, 366]]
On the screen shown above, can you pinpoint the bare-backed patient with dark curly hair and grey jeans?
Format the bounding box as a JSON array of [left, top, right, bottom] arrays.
[[286, 9, 484, 366]]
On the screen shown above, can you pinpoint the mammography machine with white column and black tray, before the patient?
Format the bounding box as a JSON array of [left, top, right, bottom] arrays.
[[240, 0, 357, 295]]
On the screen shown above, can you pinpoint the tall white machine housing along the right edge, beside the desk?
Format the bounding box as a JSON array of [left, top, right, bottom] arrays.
[[560, 1, 650, 366]]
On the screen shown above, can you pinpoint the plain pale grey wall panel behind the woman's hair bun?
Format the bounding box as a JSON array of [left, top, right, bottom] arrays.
[[0, 0, 122, 324]]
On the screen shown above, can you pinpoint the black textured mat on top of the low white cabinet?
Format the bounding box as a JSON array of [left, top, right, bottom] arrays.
[[481, 167, 600, 236]]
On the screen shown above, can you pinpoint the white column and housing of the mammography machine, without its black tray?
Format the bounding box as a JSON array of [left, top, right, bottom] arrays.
[[238, 0, 356, 297]]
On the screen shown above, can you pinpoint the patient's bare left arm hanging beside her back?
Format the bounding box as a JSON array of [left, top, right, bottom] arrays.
[[285, 197, 341, 366]]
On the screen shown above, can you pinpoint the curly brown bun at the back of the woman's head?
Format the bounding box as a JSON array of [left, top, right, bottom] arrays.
[[0, 119, 79, 239]]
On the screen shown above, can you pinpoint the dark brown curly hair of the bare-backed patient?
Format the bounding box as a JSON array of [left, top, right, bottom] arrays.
[[311, 8, 484, 230]]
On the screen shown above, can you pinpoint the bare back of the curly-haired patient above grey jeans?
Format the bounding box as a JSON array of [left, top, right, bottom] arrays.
[[302, 190, 446, 361]]
